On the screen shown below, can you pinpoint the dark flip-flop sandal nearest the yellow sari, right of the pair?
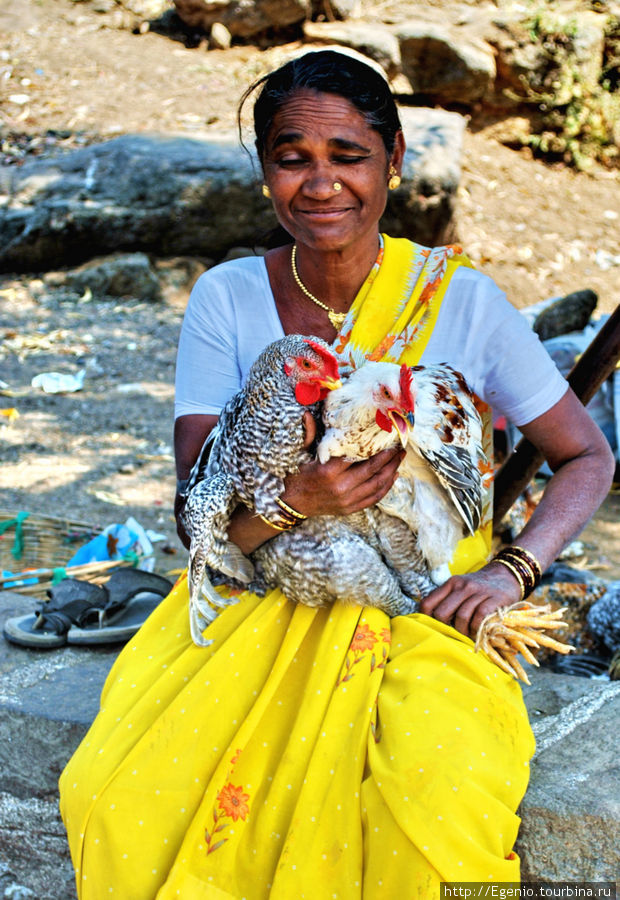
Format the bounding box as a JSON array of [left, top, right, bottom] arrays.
[[67, 568, 173, 645]]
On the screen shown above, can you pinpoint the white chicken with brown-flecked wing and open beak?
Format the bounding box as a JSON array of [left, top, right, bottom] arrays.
[[317, 363, 486, 583]]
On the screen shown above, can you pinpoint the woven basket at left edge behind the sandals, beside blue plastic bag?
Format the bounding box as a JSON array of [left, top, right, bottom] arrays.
[[0, 509, 132, 595]]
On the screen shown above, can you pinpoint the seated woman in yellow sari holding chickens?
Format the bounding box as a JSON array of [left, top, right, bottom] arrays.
[[61, 51, 613, 900]]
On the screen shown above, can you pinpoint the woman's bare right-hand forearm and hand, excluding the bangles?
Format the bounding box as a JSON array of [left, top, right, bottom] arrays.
[[420, 389, 614, 637]]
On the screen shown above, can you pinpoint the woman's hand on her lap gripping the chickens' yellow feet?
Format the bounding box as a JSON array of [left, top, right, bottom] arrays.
[[420, 562, 521, 640]]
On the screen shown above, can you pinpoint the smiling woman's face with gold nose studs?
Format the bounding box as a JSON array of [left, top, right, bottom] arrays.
[[263, 90, 404, 250]]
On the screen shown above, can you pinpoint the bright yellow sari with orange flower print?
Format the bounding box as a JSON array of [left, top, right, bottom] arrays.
[[60, 238, 534, 900]]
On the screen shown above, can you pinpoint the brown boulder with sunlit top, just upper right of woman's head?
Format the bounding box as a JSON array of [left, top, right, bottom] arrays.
[[395, 19, 495, 105]]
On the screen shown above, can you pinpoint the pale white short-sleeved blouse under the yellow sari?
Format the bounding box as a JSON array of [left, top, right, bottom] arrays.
[[175, 257, 567, 425]]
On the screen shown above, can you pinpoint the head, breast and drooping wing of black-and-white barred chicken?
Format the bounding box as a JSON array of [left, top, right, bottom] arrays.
[[182, 335, 340, 645]]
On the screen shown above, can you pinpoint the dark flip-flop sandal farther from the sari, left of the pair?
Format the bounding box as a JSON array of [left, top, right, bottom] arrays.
[[3, 578, 109, 649]]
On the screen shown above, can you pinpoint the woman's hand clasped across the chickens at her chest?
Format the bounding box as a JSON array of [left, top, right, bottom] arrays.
[[283, 448, 405, 516]]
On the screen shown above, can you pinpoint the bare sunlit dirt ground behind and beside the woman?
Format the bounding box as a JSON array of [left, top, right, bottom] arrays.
[[0, 0, 620, 578]]
